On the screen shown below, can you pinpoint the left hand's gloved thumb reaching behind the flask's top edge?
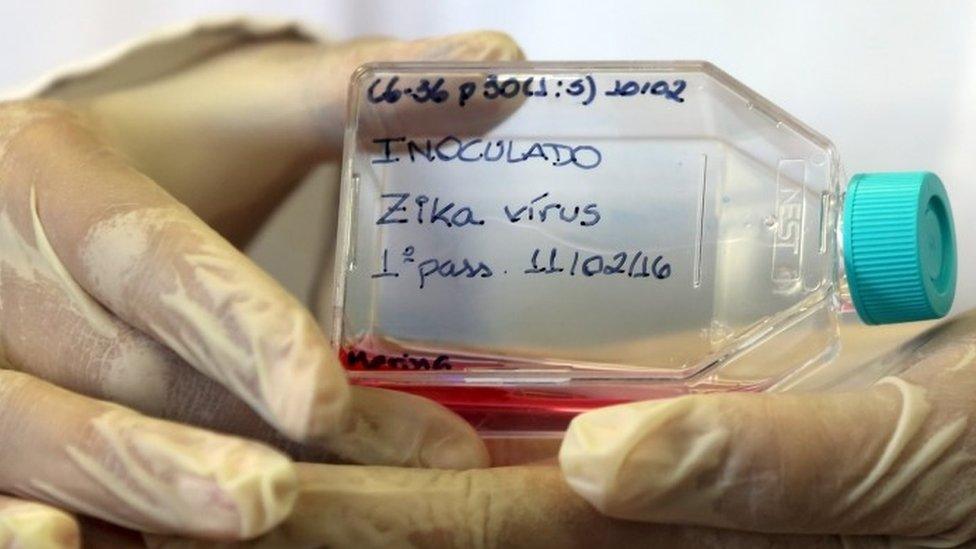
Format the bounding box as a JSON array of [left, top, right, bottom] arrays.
[[79, 31, 522, 243]]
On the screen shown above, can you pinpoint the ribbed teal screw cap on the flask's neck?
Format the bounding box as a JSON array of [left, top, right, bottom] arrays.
[[843, 172, 956, 324]]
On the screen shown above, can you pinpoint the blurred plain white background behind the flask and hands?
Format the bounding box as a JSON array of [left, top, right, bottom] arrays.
[[0, 0, 976, 312]]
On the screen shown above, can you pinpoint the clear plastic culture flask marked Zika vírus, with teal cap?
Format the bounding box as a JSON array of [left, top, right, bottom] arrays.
[[333, 62, 956, 436]]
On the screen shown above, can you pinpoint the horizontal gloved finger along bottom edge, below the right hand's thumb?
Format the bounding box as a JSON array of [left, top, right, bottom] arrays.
[[147, 464, 860, 549]]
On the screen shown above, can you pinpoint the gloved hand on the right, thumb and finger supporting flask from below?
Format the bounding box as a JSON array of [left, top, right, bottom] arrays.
[[110, 311, 976, 549]]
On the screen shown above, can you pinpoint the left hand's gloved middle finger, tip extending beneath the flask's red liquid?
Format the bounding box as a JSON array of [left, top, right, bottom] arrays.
[[0, 212, 486, 469]]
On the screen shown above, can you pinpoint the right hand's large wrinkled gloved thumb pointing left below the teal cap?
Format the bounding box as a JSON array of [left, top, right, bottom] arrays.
[[559, 312, 976, 547]]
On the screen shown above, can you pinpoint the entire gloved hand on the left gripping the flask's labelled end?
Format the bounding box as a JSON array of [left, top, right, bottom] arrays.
[[0, 28, 521, 546]]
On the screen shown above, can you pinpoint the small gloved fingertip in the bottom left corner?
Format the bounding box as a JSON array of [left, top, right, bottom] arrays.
[[0, 495, 81, 549]]
